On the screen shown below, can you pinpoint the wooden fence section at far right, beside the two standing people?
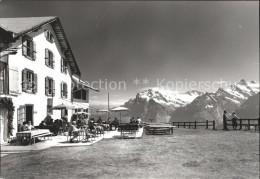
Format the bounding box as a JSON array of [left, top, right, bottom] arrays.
[[227, 118, 260, 130]]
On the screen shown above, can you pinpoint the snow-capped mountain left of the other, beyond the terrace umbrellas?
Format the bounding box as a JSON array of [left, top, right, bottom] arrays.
[[124, 88, 203, 122]]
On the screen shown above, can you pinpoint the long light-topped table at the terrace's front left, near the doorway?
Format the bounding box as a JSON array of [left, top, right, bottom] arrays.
[[16, 129, 52, 144]]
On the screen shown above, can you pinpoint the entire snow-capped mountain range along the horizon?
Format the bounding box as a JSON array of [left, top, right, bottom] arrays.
[[90, 79, 259, 125]]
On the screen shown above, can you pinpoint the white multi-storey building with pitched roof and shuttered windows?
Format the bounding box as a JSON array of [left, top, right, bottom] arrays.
[[0, 17, 96, 141]]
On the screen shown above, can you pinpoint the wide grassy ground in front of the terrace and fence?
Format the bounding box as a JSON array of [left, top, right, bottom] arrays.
[[1, 129, 259, 179]]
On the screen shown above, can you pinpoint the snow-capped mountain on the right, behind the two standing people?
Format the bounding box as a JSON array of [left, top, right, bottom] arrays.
[[171, 79, 259, 124]]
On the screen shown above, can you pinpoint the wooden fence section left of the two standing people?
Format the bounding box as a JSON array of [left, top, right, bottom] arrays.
[[172, 120, 216, 129]]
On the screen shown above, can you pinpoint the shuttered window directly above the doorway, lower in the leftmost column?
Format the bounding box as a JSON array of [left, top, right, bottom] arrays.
[[22, 69, 37, 94]]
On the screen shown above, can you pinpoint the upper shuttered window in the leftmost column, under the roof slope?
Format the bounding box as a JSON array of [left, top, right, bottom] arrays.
[[22, 36, 36, 60]]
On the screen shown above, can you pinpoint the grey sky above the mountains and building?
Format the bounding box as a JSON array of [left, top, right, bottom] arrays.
[[0, 0, 259, 105]]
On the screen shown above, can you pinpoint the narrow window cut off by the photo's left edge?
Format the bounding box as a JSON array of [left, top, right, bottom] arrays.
[[0, 56, 8, 94]]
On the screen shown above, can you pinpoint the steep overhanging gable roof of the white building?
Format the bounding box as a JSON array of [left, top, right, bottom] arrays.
[[0, 17, 81, 76]]
